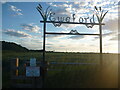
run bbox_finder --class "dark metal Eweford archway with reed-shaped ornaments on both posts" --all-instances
[36,4,108,88]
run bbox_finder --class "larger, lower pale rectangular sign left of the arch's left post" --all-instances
[26,67,40,77]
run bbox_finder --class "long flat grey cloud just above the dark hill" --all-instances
[3,29,31,37]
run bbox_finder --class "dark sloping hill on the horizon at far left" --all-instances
[0,41,29,52]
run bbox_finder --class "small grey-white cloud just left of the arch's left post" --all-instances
[21,24,41,33]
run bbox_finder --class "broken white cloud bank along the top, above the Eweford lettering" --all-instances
[49,0,118,18]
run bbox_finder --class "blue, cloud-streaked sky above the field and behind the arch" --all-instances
[0,0,120,53]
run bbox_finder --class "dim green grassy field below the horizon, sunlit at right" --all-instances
[2,51,118,88]
